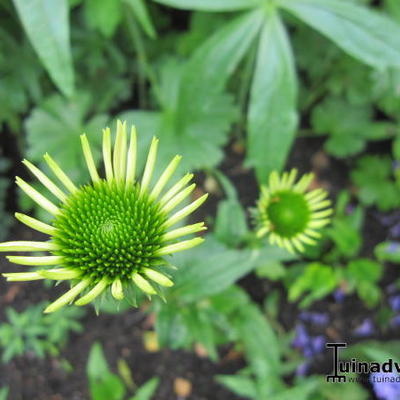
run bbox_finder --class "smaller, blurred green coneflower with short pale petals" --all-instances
[256,169,333,253]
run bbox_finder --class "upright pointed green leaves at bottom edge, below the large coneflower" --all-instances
[86,342,159,400]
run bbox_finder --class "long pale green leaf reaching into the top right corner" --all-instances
[280,0,400,68]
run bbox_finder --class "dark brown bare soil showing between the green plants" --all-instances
[0,138,399,400]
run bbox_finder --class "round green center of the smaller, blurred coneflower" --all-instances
[266,191,311,238]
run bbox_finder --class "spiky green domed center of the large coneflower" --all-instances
[53,181,166,281]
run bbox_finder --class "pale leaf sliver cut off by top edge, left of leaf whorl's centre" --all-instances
[155,0,263,11]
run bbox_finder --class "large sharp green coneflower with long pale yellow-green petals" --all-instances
[0,121,207,312]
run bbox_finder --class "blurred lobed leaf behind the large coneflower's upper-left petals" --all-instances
[26,93,109,183]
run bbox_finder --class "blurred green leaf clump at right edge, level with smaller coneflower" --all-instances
[351,155,400,211]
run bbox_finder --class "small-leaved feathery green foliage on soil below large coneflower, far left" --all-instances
[0,303,84,362]
